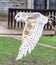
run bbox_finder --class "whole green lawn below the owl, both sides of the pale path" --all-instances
[0,36,56,65]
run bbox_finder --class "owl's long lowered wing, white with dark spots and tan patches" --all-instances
[16,14,48,60]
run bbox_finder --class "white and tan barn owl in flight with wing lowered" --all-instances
[15,12,48,60]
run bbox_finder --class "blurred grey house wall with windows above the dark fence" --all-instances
[0,0,56,14]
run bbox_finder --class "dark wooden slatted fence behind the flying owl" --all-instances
[8,8,56,30]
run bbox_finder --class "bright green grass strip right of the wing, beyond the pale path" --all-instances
[39,36,56,46]
